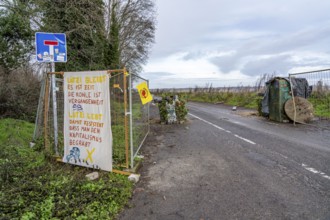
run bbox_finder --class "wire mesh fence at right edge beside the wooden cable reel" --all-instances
[289,69,330,120]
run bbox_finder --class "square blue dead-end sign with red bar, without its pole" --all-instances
[35,32,67,63]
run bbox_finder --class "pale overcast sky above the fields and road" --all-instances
[141,0,330,88]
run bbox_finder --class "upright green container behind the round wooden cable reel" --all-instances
[269,78,291,122]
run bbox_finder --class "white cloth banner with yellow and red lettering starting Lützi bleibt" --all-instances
[62,71,113,171]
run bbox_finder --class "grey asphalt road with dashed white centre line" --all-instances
[118,103,330,220]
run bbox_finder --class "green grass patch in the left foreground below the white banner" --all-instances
[0,119,132,219]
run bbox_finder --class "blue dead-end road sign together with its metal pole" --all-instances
[35,32,67,155]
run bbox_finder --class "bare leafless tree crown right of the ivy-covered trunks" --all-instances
[105,0,156,72]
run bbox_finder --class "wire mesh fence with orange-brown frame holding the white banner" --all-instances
[34,70,149,168]
